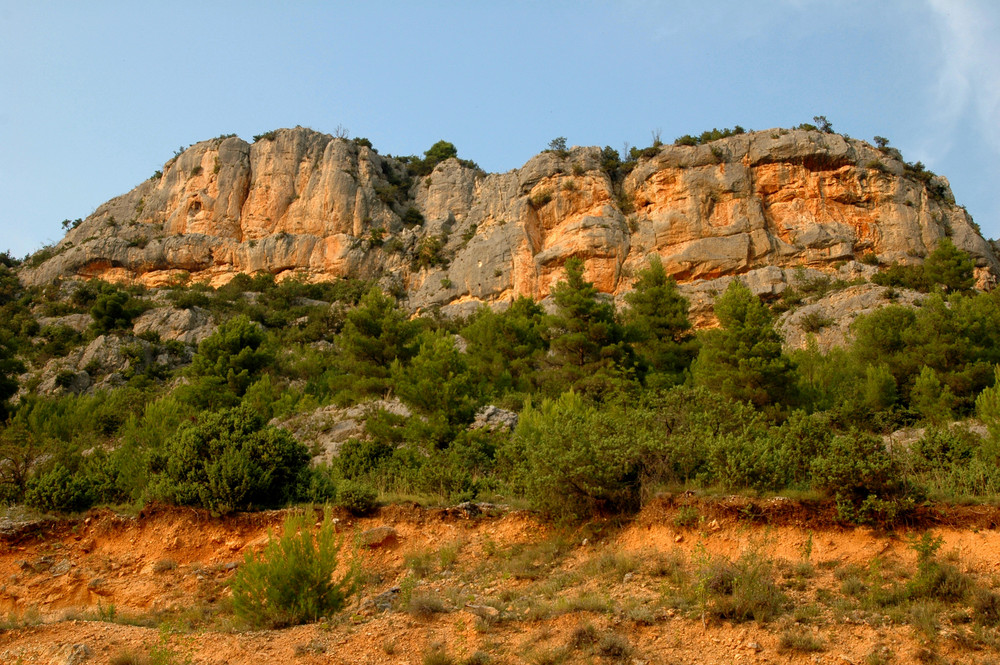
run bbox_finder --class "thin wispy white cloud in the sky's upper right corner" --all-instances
[927,0,1000,158]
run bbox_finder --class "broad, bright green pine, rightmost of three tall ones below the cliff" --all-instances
[692,280,796,407]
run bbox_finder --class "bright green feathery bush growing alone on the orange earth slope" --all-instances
[232,512,356,628]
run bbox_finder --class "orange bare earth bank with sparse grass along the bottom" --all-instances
[0,495,1000,665]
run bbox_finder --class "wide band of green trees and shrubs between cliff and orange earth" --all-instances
[0,239,1000,524]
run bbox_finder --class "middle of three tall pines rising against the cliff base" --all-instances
[625,256,698,387]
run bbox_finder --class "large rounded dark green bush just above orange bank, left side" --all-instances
[151,406,309,513]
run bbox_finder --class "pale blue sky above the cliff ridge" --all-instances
[0,0,1000,256]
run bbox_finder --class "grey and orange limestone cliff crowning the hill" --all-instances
[22,128,1000,320]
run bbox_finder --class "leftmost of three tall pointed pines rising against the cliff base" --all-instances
[546,258,635,397]
